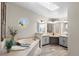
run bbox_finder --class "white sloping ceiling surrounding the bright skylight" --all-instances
[11,2,68,18]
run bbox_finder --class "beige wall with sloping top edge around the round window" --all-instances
[7,3,45,38]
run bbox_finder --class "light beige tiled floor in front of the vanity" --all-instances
[40,45,68,56]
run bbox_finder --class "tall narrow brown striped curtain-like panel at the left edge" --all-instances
[0,2,6,41]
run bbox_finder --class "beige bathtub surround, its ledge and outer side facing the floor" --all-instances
[0,38,41,56]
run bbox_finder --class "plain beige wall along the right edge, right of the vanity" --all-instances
[68,2,79,56]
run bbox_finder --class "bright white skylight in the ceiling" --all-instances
[39,2,59,11]
